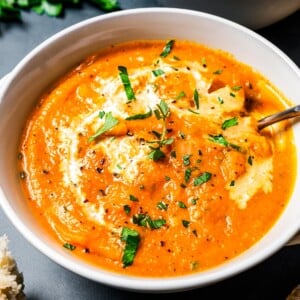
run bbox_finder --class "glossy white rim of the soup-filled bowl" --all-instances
[0,7,300,292]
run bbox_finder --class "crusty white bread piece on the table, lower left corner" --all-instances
[0,235,25,300]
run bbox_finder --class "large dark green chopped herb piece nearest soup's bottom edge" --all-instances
[121,227,140,267]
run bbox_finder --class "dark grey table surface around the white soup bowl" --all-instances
[0,0,300,300]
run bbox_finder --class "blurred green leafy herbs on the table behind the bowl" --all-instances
[0,0,120,22]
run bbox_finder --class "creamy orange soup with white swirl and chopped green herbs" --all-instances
[19,40,296,276]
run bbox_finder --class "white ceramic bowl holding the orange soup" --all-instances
[0,8,300,292]
